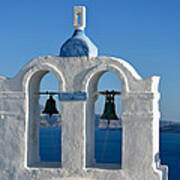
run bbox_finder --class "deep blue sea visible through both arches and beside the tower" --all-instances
[39,117,180,180]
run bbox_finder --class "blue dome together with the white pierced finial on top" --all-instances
[60,6,98,57]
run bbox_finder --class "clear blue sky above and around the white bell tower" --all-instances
[0,0,180,121]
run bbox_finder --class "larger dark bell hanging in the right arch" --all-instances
[100,91,119,125]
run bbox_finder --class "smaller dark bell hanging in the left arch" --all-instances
[42,95,59,122]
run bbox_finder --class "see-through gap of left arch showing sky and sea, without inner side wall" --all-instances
[39,72,61,163]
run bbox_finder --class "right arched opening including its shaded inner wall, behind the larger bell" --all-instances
[86,70,122,169]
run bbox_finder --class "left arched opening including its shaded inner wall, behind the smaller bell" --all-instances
[26,70,62,167]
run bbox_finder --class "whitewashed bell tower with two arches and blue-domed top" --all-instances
[0,6,167,180]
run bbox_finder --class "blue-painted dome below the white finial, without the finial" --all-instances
[60,30,98,57]
